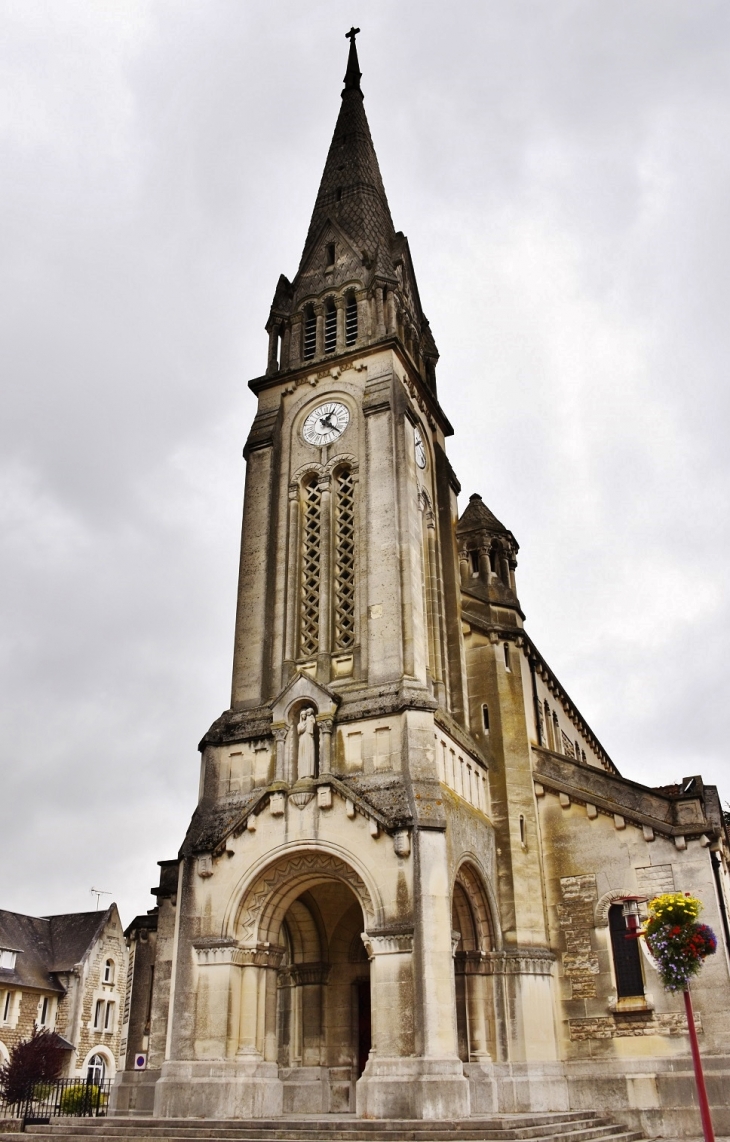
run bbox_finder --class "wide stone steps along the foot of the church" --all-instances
[2,1110,643,1142]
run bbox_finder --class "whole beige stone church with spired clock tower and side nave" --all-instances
[112,30,730,1137]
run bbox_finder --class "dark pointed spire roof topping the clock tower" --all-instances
[299,33,395,276]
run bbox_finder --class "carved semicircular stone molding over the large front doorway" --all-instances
[222,844,383,947]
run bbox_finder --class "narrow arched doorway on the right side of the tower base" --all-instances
[451,863,497,1063]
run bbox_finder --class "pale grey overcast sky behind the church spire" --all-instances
[0,0,730,923]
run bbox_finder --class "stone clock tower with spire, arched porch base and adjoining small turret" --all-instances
[117,30,562,1118]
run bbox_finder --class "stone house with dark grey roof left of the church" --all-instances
[0,904,128,1080]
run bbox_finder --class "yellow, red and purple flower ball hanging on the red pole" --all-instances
[641,892,717,991]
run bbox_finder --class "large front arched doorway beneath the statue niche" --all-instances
[230,852,375,1113]
